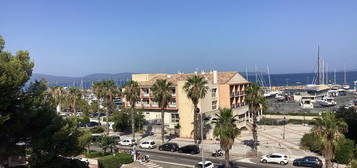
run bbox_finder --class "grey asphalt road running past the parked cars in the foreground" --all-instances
[91,146,292,168]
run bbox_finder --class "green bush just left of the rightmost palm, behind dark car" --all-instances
[300,133,322,154]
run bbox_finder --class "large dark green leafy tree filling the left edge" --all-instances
[0,37,85,167]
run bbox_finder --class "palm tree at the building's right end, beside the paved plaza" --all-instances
[245,83,266,154]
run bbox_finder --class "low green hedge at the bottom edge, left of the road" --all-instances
[98,153,133,168]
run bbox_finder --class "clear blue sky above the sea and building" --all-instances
[0,0,357,76]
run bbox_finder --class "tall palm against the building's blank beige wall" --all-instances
[183,75,208,144]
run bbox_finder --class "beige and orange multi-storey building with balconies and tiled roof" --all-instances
[124,71,250,139]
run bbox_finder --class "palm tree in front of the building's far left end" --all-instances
[123,81,140,139]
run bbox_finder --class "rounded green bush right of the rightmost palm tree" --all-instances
[335,138,355,164]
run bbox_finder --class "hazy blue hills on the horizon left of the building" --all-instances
[30,72,133,83]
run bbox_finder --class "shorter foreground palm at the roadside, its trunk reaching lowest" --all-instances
[213,108,240,167]
